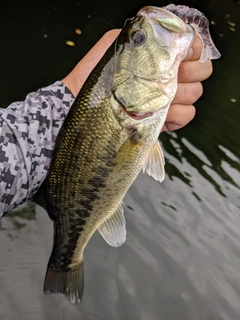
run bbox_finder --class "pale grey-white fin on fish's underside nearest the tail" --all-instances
[98,204,127,247]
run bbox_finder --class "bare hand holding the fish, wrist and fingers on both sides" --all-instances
[62,29,212,131]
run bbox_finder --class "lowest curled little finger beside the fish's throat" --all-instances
[162,104,196,132]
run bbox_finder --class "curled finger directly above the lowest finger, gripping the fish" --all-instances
[172,82,203,105]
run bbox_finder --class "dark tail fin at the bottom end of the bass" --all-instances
[44,261,84,304]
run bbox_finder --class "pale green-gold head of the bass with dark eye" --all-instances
[111,6,195,134]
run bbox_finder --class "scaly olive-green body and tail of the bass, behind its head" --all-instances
[36,41,149,303]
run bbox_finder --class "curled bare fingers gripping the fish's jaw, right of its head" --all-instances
[162,36,212,131]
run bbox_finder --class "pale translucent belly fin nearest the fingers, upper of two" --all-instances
[143,140,165,182]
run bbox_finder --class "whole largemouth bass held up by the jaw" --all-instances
[35,5,219,304]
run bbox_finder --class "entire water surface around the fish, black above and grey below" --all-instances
[0,0,240,320]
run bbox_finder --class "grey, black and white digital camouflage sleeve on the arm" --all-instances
[0,81,74,219]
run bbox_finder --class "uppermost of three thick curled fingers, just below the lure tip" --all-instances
[178,60,213,82]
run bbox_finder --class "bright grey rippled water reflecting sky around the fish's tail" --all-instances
[0,133,240,320]
